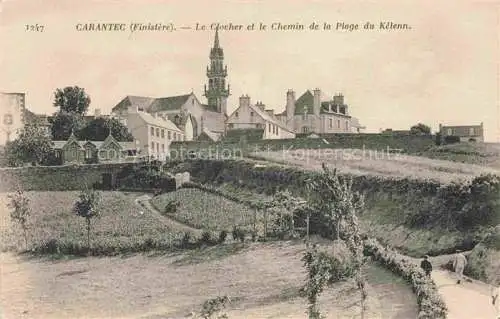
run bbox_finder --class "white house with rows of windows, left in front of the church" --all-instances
[125,107,185,160]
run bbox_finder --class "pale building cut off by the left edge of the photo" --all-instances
[0,92,26,145]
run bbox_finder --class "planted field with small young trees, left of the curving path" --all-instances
[0,191,187,253]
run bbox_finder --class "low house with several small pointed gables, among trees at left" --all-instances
[53,133,137,165]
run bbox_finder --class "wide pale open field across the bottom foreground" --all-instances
[0,242,416,319]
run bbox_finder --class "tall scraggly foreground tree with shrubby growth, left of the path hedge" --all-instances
[303,164,367,318]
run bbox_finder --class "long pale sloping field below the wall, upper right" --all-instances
[252,149,500,183]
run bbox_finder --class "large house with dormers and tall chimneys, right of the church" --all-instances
[276,89,364,134]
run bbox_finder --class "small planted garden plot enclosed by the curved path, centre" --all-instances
[152,188,254,231]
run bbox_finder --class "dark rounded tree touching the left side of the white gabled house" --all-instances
[78,118,134,142]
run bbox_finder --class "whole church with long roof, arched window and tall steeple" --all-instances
[111,30,230,141]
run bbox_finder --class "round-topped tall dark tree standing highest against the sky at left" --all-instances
[54,86,90,116]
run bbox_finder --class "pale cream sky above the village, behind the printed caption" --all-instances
[0,0,500,142]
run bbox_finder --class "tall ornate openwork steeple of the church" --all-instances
[204,28,230,114]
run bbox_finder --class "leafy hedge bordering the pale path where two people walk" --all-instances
[365,239,448,319]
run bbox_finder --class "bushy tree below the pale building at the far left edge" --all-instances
[5,123,52,166]
